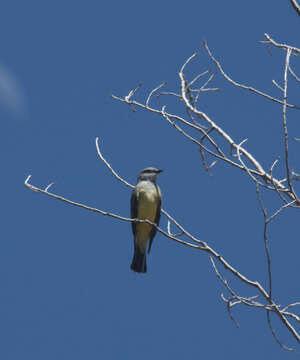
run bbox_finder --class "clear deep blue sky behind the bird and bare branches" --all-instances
[0,0,300,360]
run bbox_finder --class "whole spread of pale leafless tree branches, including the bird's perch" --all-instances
[25,34,300,351]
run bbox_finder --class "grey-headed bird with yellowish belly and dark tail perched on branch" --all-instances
[130,167,162,273]
